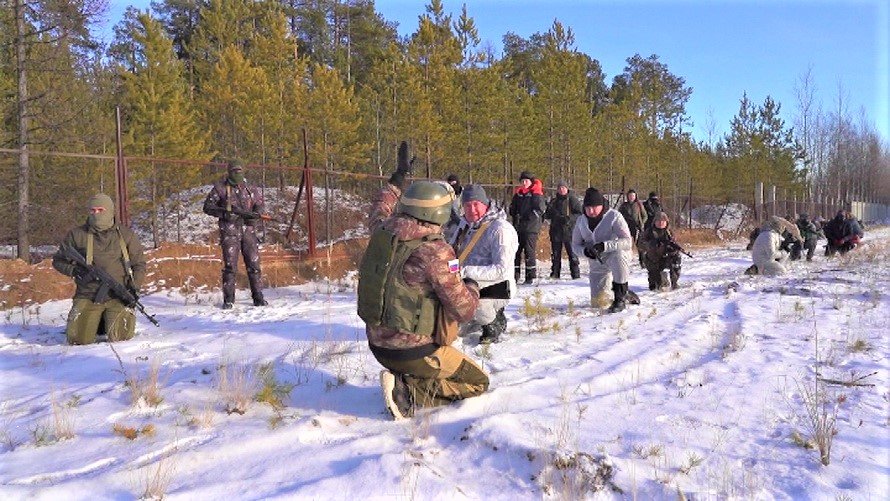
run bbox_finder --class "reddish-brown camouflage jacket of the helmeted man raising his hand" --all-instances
[365,185,479,349]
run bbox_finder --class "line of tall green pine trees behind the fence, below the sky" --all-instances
[0,0,890,256]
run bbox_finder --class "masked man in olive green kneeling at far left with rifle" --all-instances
[53,194,145,344]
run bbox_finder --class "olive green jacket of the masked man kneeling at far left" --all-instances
[53,224,145,301]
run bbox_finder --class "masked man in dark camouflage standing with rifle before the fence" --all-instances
[204,160,269,310]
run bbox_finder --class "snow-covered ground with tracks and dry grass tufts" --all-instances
[0,229,890,499]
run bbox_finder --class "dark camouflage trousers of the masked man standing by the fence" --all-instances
[219,223,263,303]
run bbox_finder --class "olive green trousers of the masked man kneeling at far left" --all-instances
[65,299,136,344]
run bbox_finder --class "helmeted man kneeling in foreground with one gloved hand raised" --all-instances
[358,143,489,419]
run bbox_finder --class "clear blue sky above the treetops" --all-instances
[102,0,890,145]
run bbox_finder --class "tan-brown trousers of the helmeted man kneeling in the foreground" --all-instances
[375,346,489,408]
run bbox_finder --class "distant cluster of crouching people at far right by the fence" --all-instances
[745,210,865,276]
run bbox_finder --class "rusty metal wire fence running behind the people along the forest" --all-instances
[0,149,850,257]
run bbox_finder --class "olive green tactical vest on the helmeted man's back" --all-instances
[358,229,442,336]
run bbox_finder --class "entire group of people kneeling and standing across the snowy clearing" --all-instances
[53,143,863,419]
